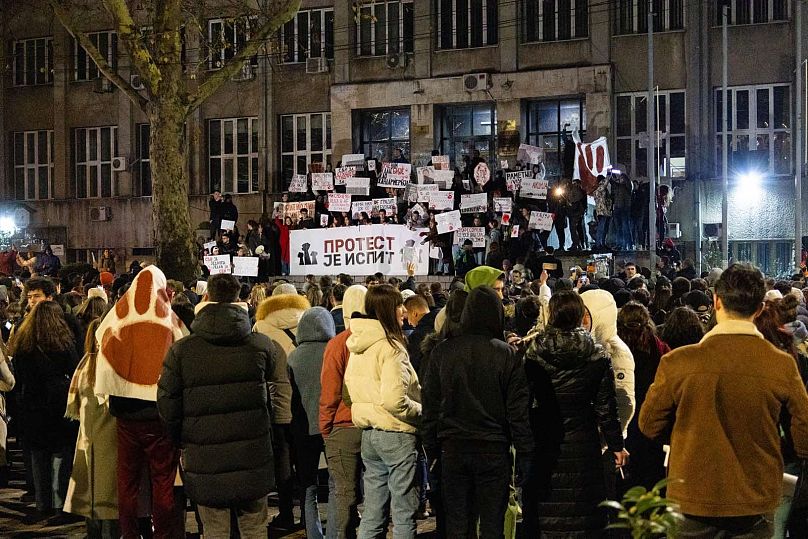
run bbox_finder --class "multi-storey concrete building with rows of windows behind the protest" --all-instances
[0,0,808,272]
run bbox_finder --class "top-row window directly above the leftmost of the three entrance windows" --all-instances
[356,1,414,56]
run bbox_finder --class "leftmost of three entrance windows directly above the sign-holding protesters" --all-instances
[358,108,410,162]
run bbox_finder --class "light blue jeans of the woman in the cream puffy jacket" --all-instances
[359,430,418,539]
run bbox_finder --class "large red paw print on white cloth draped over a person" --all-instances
[100,270,181,385]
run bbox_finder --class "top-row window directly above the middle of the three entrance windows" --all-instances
[436,0,497,49]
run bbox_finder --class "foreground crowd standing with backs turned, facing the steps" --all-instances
[0,254,808,539]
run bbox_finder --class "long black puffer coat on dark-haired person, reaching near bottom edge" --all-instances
[525,328,623,537]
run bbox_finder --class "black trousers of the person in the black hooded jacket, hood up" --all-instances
[441,444,511,539]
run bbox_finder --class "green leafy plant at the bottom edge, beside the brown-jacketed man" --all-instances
[600,479,683,539]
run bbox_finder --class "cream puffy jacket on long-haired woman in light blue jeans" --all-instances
[345,318,421,433]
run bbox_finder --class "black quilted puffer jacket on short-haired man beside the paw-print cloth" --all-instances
[157,303,278,507]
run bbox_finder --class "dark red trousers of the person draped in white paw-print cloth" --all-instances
[118,418,181,539]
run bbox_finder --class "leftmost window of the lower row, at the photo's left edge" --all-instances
[14,130,53,200]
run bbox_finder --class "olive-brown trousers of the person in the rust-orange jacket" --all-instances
[325,427,362,539]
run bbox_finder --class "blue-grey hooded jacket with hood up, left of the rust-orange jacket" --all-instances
[288,307,335,436]
